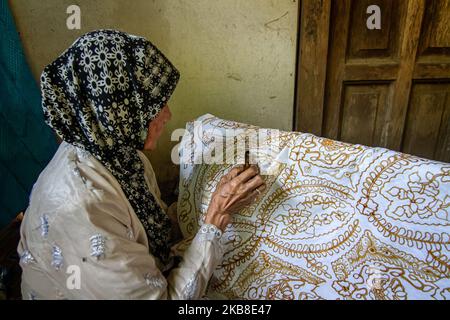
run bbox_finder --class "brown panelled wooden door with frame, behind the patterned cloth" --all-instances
[296,0,450,162]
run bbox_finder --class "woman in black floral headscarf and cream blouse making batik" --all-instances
[18,30,265,299]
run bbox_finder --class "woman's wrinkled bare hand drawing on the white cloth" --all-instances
[205,165,266,231]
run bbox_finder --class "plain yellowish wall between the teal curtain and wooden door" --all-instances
[9,0,298,186]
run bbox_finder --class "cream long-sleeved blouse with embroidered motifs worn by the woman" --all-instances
[18,142,223,299]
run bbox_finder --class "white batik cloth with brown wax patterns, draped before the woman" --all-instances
[178,115,450,299]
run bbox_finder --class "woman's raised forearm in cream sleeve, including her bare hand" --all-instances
[168,166,265,299]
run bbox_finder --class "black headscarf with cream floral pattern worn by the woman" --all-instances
[41,30,180,263]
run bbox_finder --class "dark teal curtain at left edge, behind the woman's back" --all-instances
[0,0,57,227]
